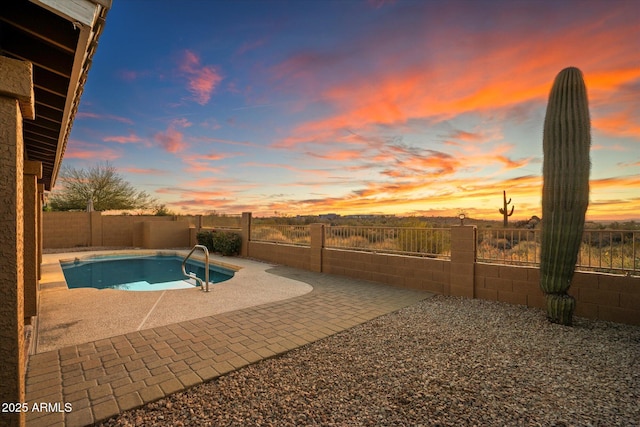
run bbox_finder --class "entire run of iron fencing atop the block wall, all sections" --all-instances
[251,224,640,275]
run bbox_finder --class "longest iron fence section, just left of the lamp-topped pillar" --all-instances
[324,226,451,258]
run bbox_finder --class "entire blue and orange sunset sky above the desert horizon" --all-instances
[63,0,640,220]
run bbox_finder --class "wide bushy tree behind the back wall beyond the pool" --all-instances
[48,162,155,211]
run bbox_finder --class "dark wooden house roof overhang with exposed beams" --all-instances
[0,0,112,190]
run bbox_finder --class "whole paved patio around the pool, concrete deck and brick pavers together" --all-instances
[26,251,432,426]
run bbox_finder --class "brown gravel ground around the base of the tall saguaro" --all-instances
[99,296,640,426]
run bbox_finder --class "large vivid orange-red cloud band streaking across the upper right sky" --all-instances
[274,3,640,152]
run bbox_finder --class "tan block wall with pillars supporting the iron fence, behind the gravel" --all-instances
[242,213,640,325]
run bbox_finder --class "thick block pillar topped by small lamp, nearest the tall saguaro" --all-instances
[449,225,477,298]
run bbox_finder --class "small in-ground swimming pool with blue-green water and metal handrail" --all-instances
[60,254,234,291]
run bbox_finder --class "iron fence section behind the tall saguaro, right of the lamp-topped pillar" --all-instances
[477,229,640,275]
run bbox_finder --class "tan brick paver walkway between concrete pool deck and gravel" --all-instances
[27,267,432,427]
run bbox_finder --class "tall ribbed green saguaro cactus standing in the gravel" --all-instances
[540,67,591,325]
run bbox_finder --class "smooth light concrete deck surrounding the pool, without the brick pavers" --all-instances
[32,250,312,353]
